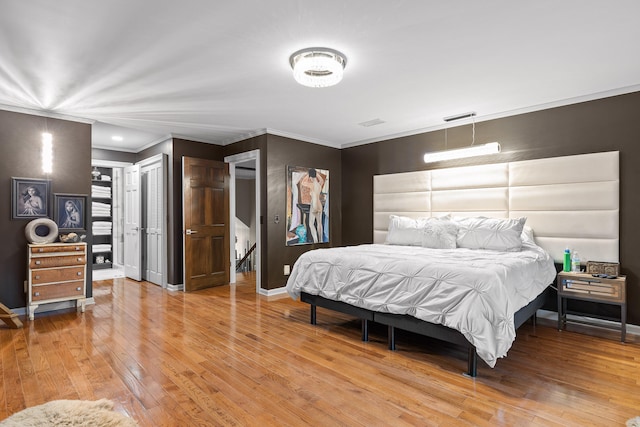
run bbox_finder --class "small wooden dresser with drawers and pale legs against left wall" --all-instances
[26,243,87,320]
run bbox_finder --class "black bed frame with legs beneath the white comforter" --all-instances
[300,288,549,377]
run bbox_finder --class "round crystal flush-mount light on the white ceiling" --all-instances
[289,47,347,87]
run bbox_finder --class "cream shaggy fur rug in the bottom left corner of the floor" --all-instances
[0,399,138,427]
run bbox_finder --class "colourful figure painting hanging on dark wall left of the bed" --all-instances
[285,166,329,246]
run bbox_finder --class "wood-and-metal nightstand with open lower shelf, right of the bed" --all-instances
[558,271,627,342]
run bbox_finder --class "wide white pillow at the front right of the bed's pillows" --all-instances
[456,217,527,251]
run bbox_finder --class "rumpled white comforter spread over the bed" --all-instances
[287,242,556,367]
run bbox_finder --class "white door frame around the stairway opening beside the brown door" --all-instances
[224,149,262,294]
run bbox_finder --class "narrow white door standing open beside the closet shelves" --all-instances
[124,165,142,281]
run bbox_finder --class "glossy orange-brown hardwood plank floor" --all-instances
[0,276,640,426]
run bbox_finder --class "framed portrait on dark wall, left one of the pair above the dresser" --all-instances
[11,177,51,219]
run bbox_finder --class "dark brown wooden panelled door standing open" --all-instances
[182,157,230,292]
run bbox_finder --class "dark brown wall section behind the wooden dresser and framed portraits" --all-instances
[0,111,92,308]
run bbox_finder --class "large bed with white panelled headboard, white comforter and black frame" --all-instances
[287,152,619,376]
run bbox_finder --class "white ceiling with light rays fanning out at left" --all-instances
[0,0,640,152]
